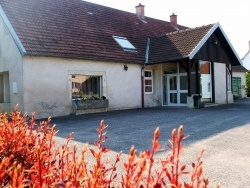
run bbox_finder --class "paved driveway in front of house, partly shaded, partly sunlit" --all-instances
[52,98,250,188]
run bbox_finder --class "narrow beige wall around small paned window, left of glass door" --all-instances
[144,64,162,107]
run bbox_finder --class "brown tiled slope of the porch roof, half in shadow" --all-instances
[149,24,214,63]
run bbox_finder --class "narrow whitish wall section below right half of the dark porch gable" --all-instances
[214,63,233,104]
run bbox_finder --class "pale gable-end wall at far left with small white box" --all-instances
[0,17,23,113]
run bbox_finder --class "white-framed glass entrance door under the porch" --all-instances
[163,74,187,106]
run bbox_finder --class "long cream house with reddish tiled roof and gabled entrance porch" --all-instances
[0,0,241,118]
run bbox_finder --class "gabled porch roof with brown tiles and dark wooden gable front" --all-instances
[148,23,242,65]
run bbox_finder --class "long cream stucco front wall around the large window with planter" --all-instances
[23,56,141,118]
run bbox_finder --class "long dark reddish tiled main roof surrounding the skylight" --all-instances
[0,0,188,63]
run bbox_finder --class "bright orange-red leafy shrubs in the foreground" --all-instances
[0,110,219,188]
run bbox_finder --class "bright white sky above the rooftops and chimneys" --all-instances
[87,0,250,58]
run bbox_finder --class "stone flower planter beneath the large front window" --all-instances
[72,99,109,115]
